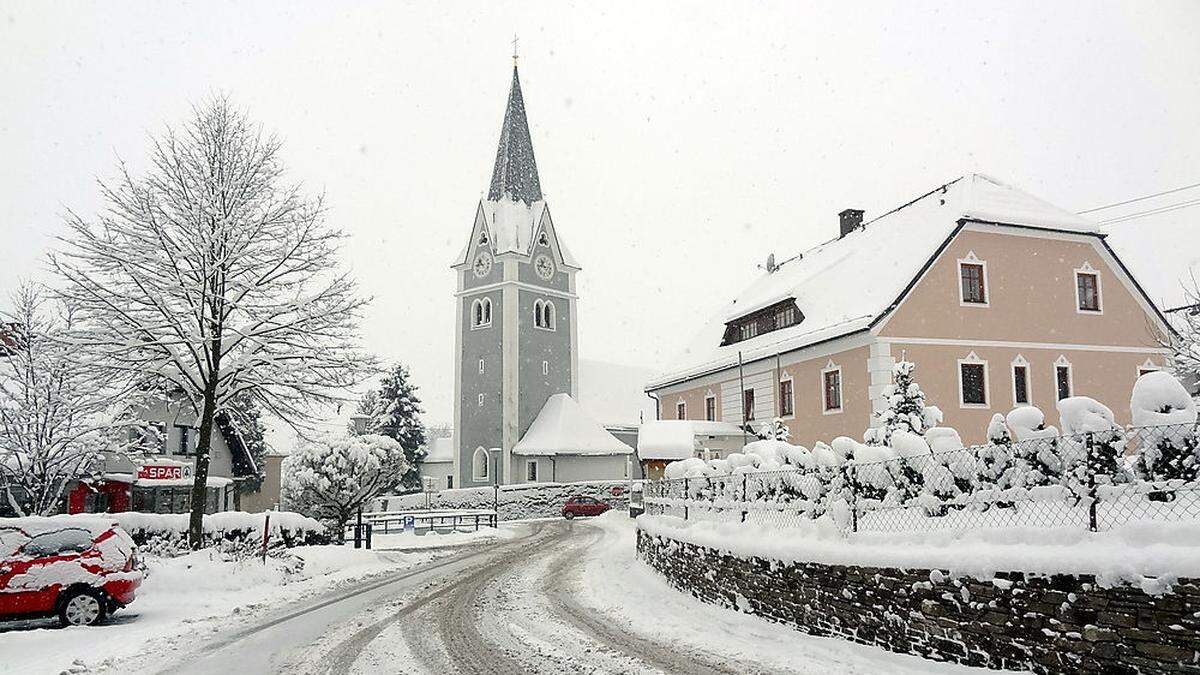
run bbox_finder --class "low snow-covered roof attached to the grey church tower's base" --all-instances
[512,394,634,455]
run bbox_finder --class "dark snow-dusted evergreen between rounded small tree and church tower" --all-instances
[350,365,428,490]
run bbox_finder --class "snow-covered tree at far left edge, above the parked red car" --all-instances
[0,283,120,515]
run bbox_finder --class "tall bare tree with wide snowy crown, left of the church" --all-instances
[52,98,371,548]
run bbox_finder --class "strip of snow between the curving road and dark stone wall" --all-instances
[578,513,983,674]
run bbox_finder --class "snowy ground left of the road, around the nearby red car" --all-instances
[0,546,434,675]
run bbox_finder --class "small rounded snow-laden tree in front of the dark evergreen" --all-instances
[281,434,410,540]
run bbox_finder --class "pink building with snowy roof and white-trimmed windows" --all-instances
[646,174,1172,446]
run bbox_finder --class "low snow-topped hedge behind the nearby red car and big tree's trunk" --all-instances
[0,510,329,556]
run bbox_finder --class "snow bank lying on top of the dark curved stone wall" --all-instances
[637,515,1200,585]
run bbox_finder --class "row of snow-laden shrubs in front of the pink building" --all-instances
[647,374,1200,526]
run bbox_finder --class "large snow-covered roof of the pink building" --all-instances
[647,174,1098,388]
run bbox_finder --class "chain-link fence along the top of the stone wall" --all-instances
[646,424,1200,532]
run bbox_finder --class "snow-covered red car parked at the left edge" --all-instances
[0,518,144,626]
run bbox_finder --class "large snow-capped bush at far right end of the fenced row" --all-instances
[1129,371,1200,480]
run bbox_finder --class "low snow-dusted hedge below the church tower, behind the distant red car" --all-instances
[372,480,630,520]
